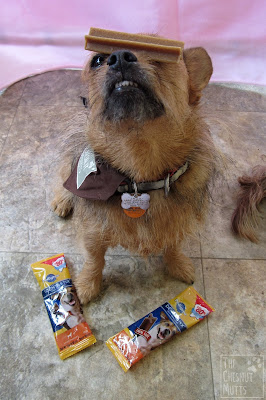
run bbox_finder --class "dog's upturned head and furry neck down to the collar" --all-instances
[83,38,212,181]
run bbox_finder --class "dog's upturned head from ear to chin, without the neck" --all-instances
[83,40,212,123]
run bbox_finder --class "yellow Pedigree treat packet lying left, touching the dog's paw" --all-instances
[31,254,96,360]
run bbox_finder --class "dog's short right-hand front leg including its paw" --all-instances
[164,245,195,284]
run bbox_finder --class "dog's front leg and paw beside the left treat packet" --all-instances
[75,238,107,304]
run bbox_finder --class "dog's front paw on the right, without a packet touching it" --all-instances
[167,254,195,285]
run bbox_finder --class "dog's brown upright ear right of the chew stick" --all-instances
[184,47,213,104]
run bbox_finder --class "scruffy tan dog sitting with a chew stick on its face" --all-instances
[52,43,215,303]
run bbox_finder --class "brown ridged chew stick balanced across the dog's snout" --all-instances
[85,28,184,62]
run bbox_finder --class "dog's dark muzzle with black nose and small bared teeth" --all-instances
[103,50,164,122]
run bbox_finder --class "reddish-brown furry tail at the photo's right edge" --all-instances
[232,165,266,243]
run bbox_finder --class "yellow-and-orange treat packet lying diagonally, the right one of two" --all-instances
[106,286,214,372]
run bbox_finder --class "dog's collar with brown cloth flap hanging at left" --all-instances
[63,157,189,200]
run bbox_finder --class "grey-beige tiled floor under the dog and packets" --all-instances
[0,71,266,400]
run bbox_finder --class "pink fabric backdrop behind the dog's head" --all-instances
[0,0,266,89]
